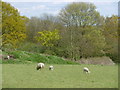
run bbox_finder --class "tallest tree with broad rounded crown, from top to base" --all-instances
[59,2,105,60]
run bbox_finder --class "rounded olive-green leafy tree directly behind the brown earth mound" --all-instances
[82,27,106,56]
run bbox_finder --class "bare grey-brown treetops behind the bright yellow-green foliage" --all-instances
[27,14,62,42]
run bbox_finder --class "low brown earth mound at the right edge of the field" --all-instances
[77,56,115,65]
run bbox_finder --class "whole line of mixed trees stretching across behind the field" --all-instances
[2,2,118,62]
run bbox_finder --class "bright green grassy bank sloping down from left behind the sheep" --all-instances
[0,51,79,64]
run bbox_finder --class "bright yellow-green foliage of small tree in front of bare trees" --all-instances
[35,29,60,47]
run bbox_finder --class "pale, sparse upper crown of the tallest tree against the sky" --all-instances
[59,2,103,27]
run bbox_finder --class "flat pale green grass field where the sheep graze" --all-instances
[2,64,118,88]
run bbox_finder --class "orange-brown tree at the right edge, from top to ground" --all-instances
[103,15,119,62]
